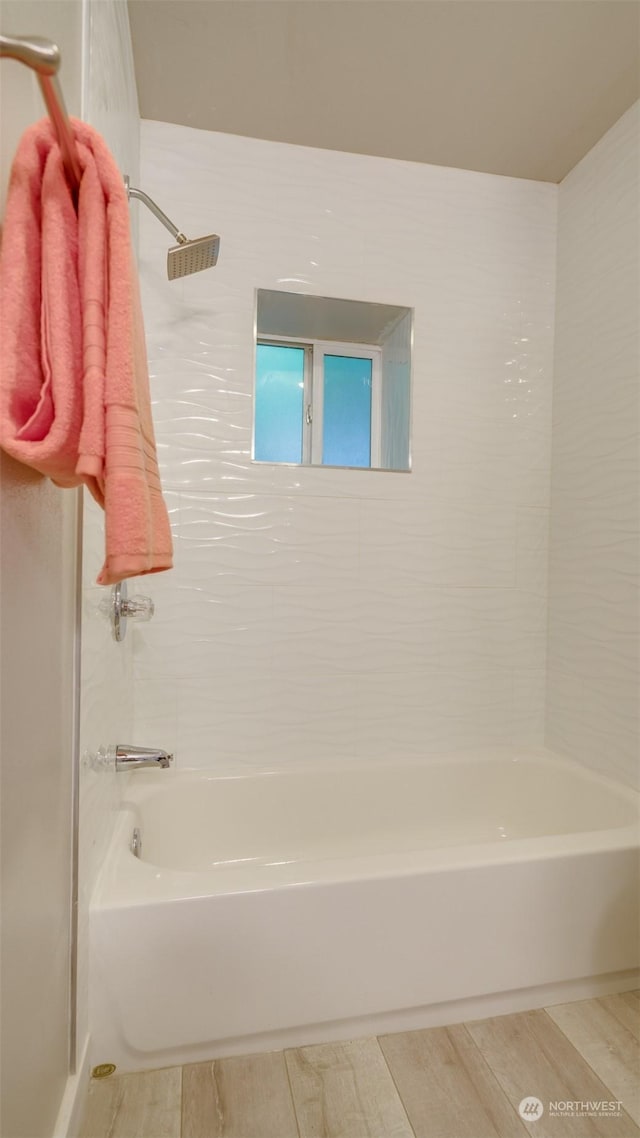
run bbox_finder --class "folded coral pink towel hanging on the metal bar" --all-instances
[0,118,172,585]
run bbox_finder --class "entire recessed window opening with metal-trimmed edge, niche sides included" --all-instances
[253,289,412,471]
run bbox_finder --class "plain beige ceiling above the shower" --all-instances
[129,0,640,182]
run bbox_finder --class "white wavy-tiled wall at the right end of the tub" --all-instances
[547,104,640,782]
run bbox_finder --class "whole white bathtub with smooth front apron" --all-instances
[90,749,639,1071]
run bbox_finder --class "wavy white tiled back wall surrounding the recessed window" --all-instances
[134,122,557,766]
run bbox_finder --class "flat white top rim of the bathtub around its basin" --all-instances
[92,748,640,909]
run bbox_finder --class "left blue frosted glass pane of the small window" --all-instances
[254,344,304,462]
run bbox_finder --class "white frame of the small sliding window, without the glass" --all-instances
[254,336,383,470]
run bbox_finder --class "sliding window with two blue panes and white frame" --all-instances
[254,339,380,467]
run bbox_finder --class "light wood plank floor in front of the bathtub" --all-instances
[80,991,640,1138]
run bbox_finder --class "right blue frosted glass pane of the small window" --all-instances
[322,355,372,467]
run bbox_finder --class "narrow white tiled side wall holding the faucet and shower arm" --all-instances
[77,0,140,1065]
